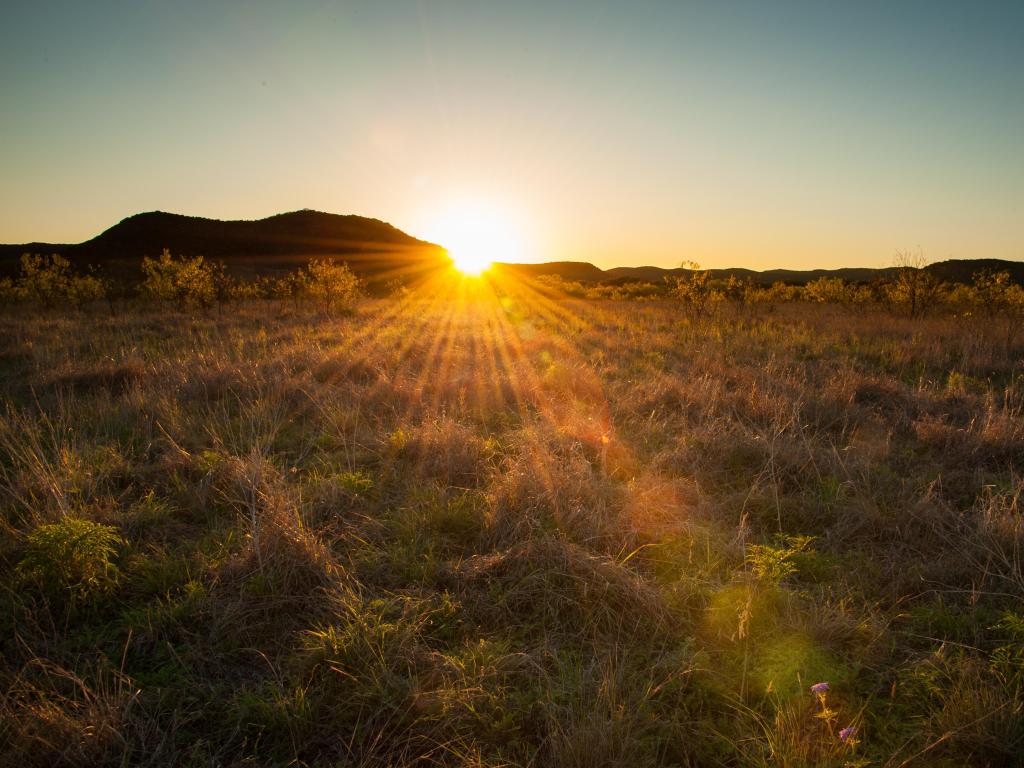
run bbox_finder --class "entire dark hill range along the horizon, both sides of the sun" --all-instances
[0,209,1024,285]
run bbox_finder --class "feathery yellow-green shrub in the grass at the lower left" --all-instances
[17,517,123,603]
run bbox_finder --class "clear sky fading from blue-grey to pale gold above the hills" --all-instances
[0,0,1024,269]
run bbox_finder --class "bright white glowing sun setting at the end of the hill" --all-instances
[421,203,523,276]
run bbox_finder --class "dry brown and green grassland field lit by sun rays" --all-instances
[0,282,1024,768]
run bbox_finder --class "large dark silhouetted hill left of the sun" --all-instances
[0,210,450,278]
